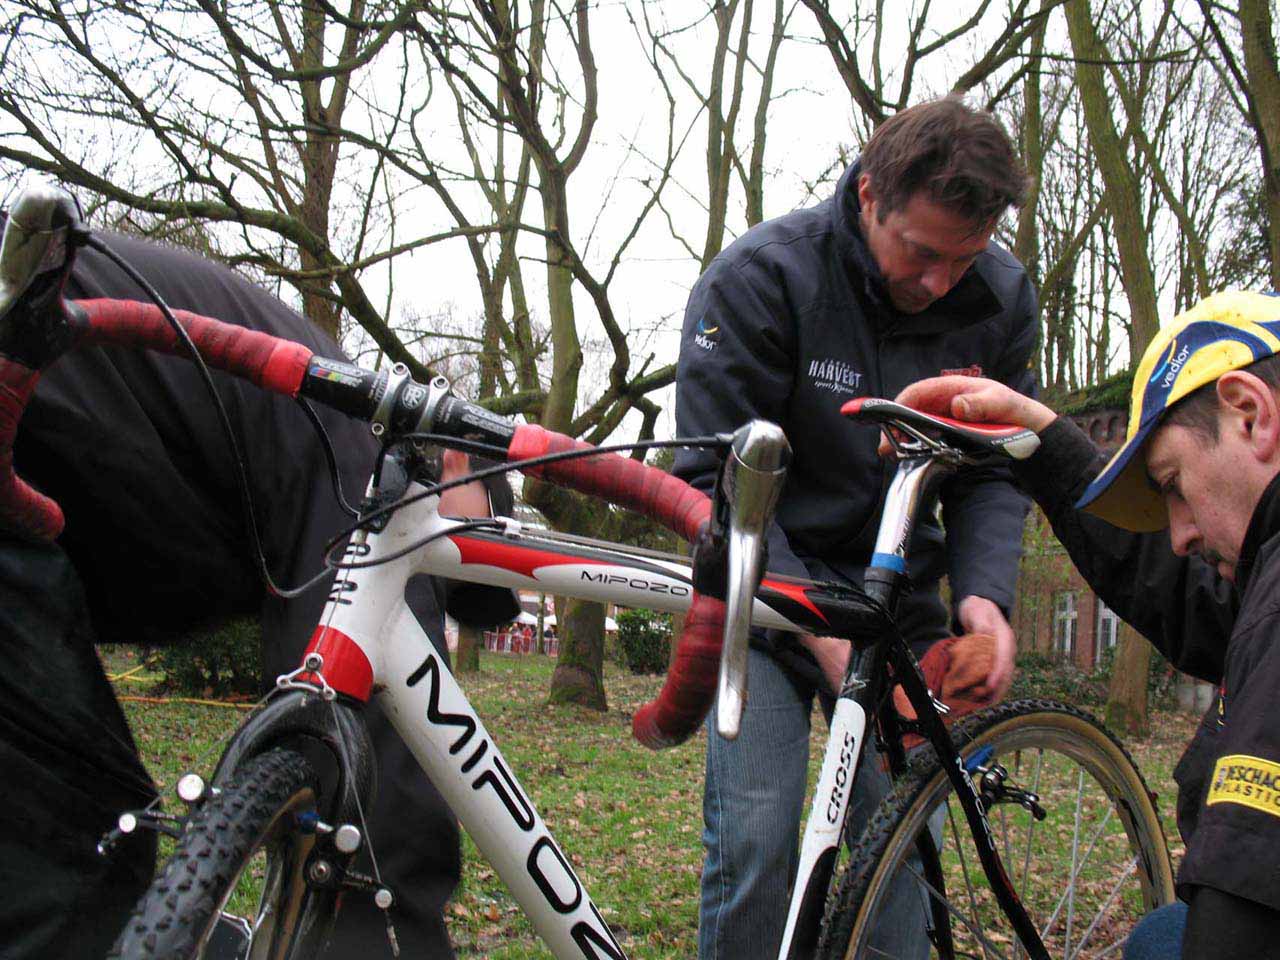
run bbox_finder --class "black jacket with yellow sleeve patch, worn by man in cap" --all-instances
[1015,419,1280,957]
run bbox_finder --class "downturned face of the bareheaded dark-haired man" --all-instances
[858,174,996,314]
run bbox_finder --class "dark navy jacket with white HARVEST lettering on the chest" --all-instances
[675,164,1037,675]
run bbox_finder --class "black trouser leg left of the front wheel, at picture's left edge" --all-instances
[0,540,155,960]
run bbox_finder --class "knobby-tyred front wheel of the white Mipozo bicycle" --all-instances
[110,750,335,960]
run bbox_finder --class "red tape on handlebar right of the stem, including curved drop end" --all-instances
[507,425,724,750]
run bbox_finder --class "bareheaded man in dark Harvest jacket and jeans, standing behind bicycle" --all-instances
[675,97,1037,960]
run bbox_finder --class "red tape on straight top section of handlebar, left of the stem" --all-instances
[79,300,312,397]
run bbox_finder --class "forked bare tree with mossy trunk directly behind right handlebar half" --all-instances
[417,0,696,709]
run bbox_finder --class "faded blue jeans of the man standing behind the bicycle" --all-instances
[698,649,928,960]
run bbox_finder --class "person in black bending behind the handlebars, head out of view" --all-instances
[0,218,518,960]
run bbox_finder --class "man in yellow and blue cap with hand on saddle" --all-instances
[899,292,1280,960]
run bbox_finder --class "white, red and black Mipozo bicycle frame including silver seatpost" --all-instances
[267,437,1039,960]
